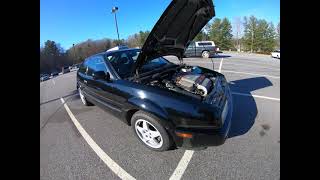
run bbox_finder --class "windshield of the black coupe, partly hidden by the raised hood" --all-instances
[105,49,170,78]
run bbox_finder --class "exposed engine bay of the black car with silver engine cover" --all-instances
[146,65,216,99]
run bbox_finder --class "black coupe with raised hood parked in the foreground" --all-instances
[77,0,233,151]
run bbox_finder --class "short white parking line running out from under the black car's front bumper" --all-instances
[169,150,194,180]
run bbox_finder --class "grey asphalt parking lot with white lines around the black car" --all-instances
[40,53,280,179]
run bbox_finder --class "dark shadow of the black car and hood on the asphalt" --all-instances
[228,77,273,138]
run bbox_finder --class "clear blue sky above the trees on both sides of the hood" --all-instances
[40,0,280,50]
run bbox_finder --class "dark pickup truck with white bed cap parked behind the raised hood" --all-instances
[184,41,219,58]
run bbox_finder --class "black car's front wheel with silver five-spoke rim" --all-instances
[131,111,173,151]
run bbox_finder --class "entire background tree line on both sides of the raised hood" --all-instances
[40,16,280,73]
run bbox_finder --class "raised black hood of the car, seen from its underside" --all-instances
[133,0,215,73]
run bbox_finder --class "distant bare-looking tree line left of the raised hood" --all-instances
[40,31,150,73]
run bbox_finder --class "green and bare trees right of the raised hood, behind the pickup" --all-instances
[195,16,280,54]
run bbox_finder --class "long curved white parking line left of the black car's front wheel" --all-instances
[61,98,135,180]
